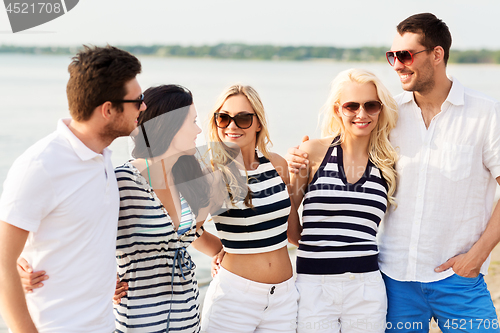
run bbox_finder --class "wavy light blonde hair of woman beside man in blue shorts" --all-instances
[321,68,398,206]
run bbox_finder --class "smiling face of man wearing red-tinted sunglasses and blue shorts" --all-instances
[391,32,434,94]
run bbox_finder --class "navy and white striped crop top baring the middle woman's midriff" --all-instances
[213,152,290,254]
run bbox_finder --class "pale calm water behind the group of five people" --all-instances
[0,54,500,332]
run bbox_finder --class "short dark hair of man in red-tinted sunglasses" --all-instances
[397,13,451,65]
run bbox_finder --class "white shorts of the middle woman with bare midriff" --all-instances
[201,267,299,333]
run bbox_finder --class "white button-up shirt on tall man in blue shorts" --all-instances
[378,79,500,282]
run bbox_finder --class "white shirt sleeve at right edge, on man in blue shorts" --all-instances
[483,102,500,178]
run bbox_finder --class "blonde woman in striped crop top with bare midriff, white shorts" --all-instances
[201,85,298,333]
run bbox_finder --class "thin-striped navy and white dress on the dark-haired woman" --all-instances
[115,163,200,333]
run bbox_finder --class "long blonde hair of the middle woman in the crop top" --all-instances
[208,84,272,207]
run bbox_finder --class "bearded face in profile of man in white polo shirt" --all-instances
[105,79,146,139]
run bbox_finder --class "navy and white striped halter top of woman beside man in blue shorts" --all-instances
[297,141,387,275]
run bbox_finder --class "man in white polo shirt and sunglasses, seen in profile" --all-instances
[0,46,146,333]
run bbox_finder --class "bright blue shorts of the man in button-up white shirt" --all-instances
[383,274,500,333]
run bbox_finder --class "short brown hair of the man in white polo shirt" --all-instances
[66,45,141,121]
